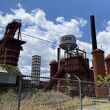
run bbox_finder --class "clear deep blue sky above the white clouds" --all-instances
[0,0,110,42]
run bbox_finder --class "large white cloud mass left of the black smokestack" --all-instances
[0,5,90,75]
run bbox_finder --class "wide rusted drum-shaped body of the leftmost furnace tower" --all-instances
[0,38,26,66]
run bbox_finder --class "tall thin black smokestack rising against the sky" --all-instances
[90,15,97,50]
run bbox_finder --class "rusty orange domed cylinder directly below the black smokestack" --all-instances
[92,49,106,98]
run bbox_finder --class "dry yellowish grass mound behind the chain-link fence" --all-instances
[0,91,94,110]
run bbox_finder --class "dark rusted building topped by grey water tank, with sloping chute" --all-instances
[46,35,90,90]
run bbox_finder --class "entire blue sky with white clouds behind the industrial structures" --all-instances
[0,0,110,74]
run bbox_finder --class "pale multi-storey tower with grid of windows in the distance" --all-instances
[31,55,41,83]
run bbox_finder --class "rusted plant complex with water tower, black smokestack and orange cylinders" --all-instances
[45,15,110,98]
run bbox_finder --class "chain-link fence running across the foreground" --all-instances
[0,74,108,110]
